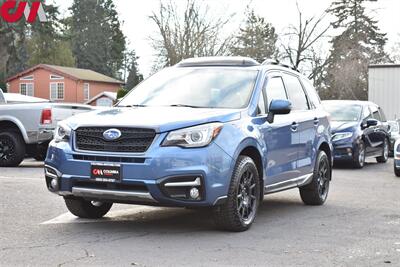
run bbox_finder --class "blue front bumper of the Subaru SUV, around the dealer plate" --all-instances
[45,134,233,206]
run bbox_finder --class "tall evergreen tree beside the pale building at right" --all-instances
[323,0,388,100]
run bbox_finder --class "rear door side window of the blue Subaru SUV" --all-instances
[285,75,309,110]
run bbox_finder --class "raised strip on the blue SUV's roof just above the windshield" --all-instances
[175,57,260,67]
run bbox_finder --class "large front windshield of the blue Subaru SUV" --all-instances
[118,68,258,108]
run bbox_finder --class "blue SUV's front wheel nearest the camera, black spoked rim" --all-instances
[213,156,260,232]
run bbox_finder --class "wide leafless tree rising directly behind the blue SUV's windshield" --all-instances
[150,0,232,68]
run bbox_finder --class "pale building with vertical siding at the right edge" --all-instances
[368,64,400,120]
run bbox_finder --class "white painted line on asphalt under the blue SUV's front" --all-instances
[40,206,161,225]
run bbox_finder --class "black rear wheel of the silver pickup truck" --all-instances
[0,132,25,167]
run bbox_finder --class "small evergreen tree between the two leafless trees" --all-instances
[231,10,278,62]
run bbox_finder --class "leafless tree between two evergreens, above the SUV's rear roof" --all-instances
[282,3,331,74]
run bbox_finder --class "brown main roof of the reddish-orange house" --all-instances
[7,64,124,84]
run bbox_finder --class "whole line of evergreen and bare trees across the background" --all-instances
[0,0,400,100]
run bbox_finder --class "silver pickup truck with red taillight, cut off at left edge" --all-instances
[0,89,93,167]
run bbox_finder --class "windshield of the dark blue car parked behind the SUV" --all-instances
[324,104,362,121]
